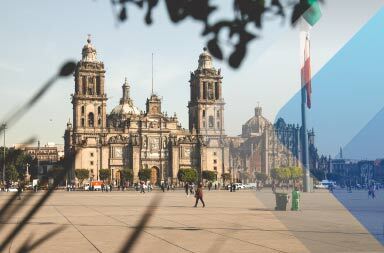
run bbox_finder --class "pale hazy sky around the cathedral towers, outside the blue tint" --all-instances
[0,0,383,156]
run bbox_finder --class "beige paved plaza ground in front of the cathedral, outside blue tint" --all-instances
[0,189,384,253]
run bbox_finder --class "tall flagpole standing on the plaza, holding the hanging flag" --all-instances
[301,31,311,192]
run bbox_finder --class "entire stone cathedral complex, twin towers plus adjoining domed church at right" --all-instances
[64,36,314,184]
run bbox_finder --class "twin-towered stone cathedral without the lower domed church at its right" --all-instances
[64,38,230,184]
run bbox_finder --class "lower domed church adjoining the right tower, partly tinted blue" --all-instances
[229,106,317,182]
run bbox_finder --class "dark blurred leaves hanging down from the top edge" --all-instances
[111,0,323,68]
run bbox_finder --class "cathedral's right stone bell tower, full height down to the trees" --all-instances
[188,48,229,180]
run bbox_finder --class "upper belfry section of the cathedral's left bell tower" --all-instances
[72,36,107,132]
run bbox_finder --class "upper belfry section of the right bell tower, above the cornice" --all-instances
[188,48,225,138]
